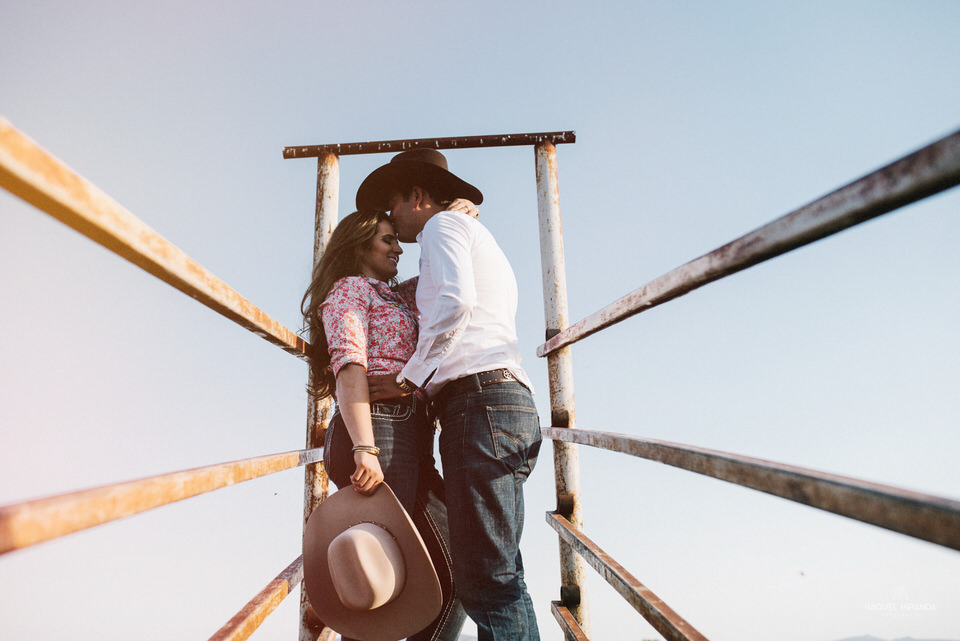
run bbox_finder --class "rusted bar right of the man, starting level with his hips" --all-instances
[542,428,960,550]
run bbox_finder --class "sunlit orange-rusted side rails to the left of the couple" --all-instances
[0,118,318,641]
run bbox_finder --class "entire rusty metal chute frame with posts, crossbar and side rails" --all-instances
[0,119,960,641]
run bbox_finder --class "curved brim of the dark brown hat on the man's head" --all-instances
[357,160,483,211]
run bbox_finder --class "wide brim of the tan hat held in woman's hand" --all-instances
[303,483,442,641]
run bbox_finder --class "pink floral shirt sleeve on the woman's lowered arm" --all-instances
[320,277,371,376]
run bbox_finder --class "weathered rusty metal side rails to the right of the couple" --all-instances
[537,126,960,641]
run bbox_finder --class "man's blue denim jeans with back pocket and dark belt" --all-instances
[434,382,541,641]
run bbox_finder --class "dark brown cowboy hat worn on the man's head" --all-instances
[357,149,483,211]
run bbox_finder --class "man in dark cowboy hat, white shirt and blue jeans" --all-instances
[357,149,541,641]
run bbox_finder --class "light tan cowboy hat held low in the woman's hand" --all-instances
[303,483,442,641]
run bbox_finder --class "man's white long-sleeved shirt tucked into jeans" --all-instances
[402,212,530,396]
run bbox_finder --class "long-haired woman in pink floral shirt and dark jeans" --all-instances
[301,204,466,641]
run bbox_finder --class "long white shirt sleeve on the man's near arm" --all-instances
[403,212,477,387]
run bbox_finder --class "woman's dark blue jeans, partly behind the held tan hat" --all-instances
[323,399,467,641]
